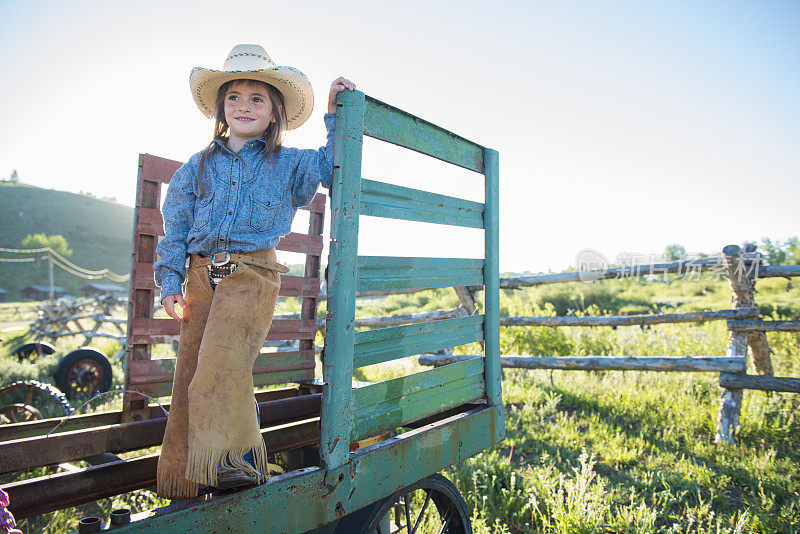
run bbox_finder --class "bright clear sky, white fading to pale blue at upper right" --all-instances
[0,0,800,271]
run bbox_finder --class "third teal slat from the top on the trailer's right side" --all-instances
[357,256,484,291]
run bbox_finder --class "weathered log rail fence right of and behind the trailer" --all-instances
[412,245,800,443]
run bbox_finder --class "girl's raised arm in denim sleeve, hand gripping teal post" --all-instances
[292,77,356,208]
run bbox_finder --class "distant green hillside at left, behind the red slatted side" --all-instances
[0,182,133,300]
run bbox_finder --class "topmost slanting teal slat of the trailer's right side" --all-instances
[364,97,483,173]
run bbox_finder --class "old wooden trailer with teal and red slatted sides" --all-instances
[0,91,505,534]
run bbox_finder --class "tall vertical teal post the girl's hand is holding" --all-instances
[320,91,364,469]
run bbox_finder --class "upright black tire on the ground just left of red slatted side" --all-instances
[53,347,113,400]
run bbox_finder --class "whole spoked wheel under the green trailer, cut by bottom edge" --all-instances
[336,474,472,534]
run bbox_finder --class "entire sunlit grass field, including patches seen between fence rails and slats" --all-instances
[0,280,800,534]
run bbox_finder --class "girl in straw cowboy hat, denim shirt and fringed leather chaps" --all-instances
[153,45,355,498]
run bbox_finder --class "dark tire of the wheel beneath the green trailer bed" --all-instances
[336,474,472,534]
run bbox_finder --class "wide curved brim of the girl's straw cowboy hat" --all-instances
[189,66,314,130]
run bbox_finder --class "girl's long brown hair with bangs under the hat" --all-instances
[197,79,289,197]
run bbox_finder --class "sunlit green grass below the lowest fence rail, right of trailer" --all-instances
[448,370,800,533]
